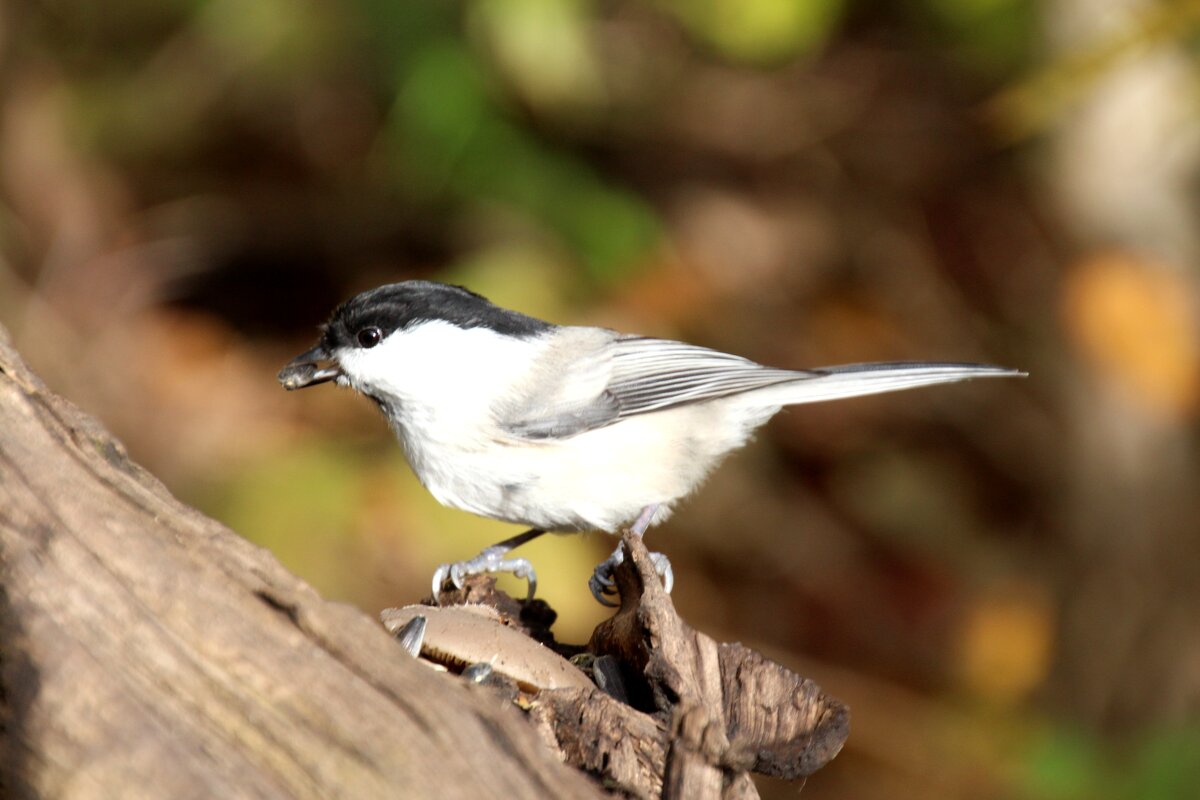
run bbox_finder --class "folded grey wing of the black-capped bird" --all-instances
[502,333,811,439]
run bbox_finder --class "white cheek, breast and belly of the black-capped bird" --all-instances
[340,321,774,531]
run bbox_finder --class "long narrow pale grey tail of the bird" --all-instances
[764,361,1027,405]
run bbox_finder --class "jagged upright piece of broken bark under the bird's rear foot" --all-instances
[589,535,850,798]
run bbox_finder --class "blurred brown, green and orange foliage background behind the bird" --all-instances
[0,0,1200,799]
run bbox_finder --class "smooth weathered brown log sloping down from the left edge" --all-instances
[0,330,601,799]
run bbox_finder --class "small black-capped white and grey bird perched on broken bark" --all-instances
[278,281,1025,604]
